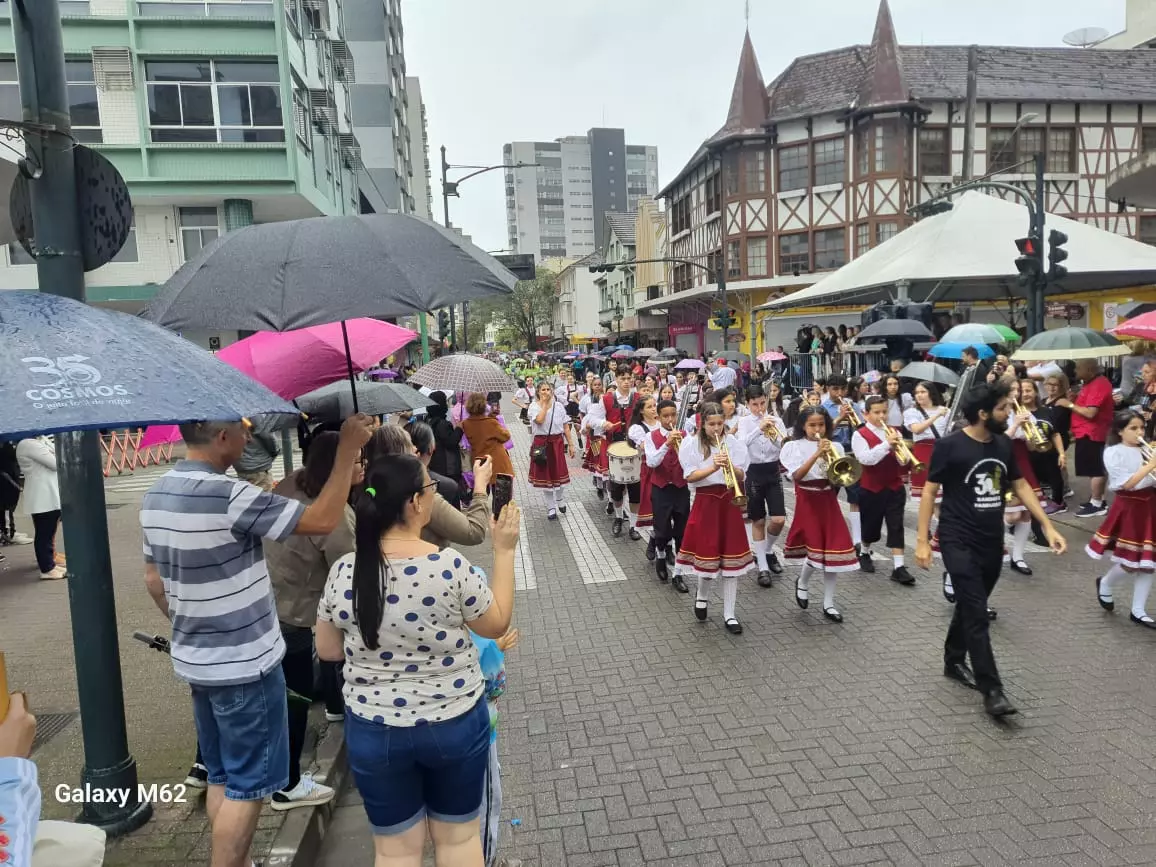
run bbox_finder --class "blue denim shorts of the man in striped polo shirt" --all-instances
[193,665,289,801]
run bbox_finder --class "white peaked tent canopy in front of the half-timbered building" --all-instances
[758,191,1156,310]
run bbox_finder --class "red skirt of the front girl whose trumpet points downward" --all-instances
[677,484,755,578]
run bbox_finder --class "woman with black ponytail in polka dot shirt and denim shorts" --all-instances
[316,454,520,867]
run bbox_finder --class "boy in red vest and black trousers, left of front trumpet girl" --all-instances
[644,400,690,593]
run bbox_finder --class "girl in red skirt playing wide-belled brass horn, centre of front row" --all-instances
[779,407,859,623]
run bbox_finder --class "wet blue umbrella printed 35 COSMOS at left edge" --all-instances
[0,291,298,439]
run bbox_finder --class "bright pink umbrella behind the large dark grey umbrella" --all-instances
[217,319,417,400]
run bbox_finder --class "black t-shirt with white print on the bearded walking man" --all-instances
[927,430,1020,550]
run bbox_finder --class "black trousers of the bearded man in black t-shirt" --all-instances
[940,538,1003,695]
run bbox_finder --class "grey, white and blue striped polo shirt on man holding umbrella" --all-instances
[141,460,305,687]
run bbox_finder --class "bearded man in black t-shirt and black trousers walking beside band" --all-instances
[916,383,1067,717]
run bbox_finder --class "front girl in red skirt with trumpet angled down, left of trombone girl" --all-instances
[677,403,755,635]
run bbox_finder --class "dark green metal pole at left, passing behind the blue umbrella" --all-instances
[12,0,153,836]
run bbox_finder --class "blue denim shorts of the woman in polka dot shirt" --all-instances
[346,698,490,837]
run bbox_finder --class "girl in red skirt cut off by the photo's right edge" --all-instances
[1084,410,1156,629]
